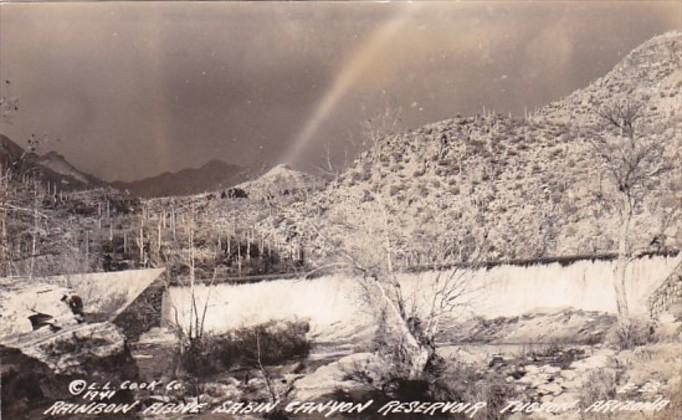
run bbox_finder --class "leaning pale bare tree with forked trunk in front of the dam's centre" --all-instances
[306,186,480,380]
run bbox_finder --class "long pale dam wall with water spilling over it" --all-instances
[162,255,682,336]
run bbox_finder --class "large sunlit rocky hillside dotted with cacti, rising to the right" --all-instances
[248,32,682,264]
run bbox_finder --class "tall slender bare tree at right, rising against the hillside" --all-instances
[590,99,674,319]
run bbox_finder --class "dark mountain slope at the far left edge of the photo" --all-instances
[0,134,106,191]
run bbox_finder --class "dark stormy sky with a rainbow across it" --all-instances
[0,1,682,181]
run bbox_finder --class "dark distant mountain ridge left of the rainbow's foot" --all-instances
[112,160,250,198]
